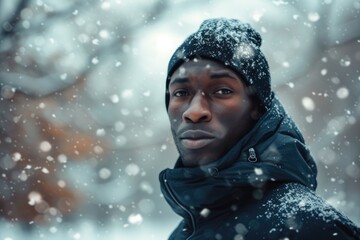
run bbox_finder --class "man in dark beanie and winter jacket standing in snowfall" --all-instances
[160,18,360,240]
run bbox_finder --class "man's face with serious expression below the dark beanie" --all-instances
[168,59,257,166]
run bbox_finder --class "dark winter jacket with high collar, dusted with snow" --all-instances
[160,98,360,240]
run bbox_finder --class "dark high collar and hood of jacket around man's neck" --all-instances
[160,94,317,215]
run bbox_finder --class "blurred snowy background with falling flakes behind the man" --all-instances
[0,0,360,240]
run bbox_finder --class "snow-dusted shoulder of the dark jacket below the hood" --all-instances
[259,183,360,239]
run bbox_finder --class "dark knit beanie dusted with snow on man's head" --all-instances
[165,18,272,109]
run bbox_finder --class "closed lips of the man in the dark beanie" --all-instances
[180,130,215,149]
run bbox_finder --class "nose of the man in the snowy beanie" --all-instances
[183,93,211,123]
